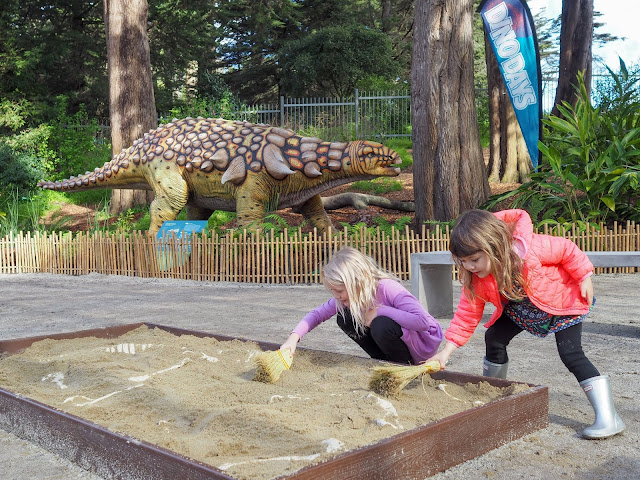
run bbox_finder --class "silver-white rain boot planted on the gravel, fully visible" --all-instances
[580,375,625,439]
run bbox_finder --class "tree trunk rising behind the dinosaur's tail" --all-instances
[104,0,158,214]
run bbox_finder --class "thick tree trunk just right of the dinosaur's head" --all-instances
[411,0,490,229]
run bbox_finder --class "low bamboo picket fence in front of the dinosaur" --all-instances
[0,222,640,284]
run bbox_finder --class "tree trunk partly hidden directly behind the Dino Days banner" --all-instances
[485,35,532,183]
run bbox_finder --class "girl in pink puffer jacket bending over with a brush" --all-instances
[432,210,625,438]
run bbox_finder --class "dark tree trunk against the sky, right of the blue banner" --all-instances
[551,0,593,116]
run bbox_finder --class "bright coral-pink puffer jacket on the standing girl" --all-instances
[445,210,593,347]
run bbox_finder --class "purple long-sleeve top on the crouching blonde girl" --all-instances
[292,278,442,363]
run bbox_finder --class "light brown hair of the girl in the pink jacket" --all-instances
[449,210,525,300]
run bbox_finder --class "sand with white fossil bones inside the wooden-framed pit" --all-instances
[0,326,529,480]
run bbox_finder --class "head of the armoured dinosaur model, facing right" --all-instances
[343,140,402,177]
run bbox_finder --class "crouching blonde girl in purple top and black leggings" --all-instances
[281,247,442,364]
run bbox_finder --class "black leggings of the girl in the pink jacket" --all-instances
[484,315,600,382]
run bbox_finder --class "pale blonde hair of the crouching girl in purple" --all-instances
[323,247,398,334]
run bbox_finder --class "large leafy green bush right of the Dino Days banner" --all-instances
[485,60,640,223]
